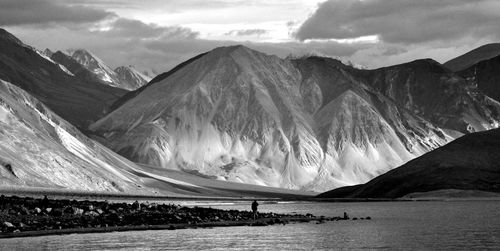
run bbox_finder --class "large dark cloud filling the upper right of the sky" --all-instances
[295,0,500,44]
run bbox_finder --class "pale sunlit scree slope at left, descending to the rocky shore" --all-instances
[0,80,147,192]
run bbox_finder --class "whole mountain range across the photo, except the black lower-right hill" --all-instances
[0,30,500,196]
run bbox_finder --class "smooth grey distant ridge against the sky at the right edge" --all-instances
[444,43,500,72]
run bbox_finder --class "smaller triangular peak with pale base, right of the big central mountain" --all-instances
[294,57,451,190]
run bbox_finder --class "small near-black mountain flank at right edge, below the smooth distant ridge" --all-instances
[458,56,500,102]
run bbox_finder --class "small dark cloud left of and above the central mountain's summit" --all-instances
[95,18,199,39]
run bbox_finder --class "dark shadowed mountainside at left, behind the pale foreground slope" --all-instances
[0,29,125,128]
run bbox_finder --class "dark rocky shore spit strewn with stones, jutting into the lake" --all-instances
[0,196,370,238]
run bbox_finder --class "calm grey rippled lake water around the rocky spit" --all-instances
[0,201,500,250]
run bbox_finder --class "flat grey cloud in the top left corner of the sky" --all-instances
[0,0,115,26]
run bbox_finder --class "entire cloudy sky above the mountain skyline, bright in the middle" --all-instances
[0,0,500,72]
